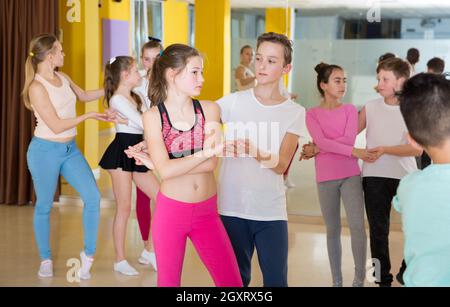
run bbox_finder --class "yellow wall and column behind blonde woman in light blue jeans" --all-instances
[59,0,131,169]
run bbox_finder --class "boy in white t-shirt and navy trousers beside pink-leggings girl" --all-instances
[218,33,306,287]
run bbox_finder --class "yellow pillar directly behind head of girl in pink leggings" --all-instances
[195,0,231,100]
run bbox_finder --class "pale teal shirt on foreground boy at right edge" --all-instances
[393,164,450,287]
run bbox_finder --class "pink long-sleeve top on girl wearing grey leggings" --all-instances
[306,104,361,182]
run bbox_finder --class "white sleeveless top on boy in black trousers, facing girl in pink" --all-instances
[362,98,417,179]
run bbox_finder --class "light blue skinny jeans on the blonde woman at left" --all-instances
[27,137,100,260]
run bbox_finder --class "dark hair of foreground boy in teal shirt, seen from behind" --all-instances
[399,73,450,147]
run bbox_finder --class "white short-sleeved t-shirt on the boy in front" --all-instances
[218,89,306,221]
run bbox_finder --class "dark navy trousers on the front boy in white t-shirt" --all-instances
[221,216,288,287]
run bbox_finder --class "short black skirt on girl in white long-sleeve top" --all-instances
[99,133,148,173]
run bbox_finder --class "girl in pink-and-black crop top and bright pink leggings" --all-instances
[127,44,242,287]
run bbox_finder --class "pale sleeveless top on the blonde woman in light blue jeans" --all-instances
[34,72,77,139]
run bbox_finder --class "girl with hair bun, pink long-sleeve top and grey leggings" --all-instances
[306,63,372,286]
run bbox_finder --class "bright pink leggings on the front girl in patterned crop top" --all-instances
[152,193,242,287]
